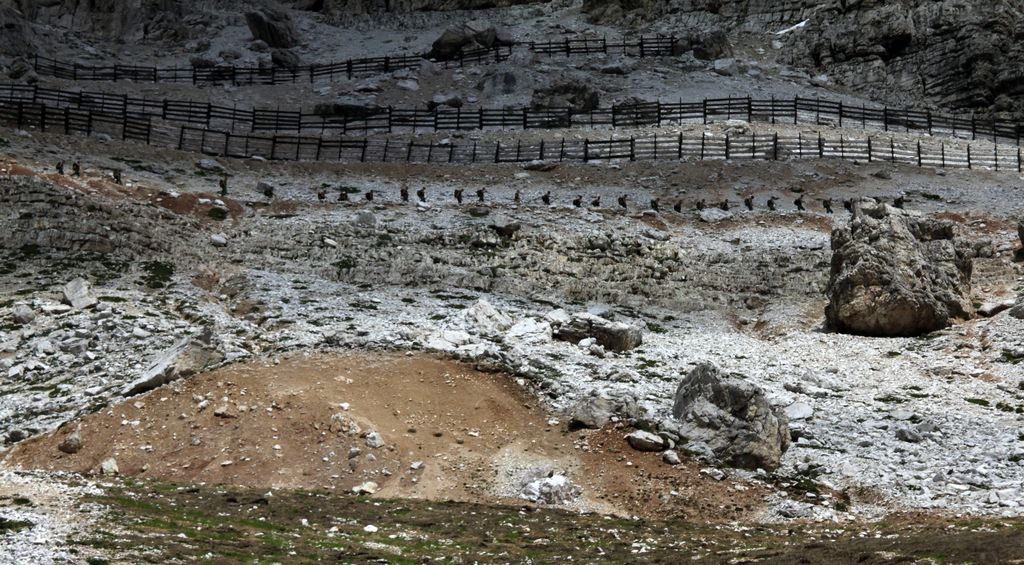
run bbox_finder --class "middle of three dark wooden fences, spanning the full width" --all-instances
[0,84,1022,145]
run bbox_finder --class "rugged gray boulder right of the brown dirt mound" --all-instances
[672,363,790,471]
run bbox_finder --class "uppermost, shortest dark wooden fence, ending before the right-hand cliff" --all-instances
[33,36,680,86]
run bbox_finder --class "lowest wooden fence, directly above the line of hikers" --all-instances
[0,100,1021,173]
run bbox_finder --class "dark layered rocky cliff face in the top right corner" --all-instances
[780,0,1024,112]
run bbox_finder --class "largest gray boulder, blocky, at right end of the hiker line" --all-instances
[825,200,973,337]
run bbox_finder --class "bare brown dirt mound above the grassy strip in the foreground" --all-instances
[6,352,764,521]
